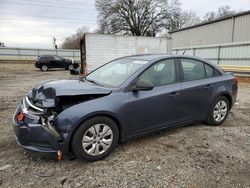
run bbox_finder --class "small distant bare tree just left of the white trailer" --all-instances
[62,26,89,49]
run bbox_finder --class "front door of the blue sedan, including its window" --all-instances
[126,59,180,135]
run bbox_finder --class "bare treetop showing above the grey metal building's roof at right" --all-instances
[203,5,236,21]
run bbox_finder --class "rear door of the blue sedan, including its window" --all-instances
[179,58,213,121]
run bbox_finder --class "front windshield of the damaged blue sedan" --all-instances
[86,59,147,87]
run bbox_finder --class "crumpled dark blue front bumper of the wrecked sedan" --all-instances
[12,97,65,154]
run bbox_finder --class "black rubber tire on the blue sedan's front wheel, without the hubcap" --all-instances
[71,116,119,161]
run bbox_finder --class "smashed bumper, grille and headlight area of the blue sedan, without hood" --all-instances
[13,96,63,156]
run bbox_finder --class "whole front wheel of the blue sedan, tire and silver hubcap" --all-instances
[72,116,119,161]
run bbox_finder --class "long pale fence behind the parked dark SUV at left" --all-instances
[0,47,80,61]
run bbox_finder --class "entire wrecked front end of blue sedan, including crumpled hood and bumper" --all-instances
[13,80,111,159]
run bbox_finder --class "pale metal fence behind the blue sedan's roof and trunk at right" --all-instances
[172,42,250,72]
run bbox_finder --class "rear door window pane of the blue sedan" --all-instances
[181,58,206,81]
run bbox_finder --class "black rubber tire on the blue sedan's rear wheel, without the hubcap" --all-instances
[206,96,230,126]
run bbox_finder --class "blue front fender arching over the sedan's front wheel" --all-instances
[55,96,126,152]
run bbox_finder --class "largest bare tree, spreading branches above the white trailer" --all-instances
[96,0,188,36]
